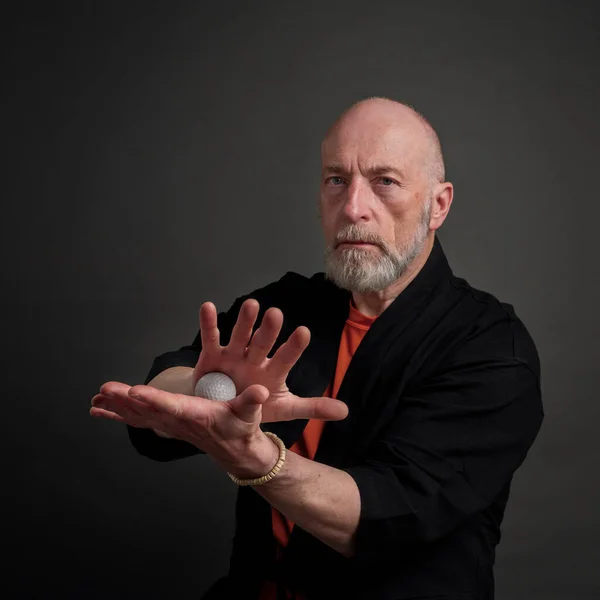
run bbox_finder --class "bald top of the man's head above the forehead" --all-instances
[321,97,445,185]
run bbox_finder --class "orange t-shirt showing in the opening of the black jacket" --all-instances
[259,300,377,600]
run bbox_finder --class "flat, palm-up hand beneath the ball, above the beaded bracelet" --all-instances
[90,381,279,478]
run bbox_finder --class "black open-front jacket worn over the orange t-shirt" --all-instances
[128,238,543,600]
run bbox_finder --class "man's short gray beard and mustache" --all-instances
[325,202,431,294]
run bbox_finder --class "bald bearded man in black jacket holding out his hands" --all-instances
[91,98,543,600]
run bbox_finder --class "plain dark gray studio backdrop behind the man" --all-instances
[1,0,600,600]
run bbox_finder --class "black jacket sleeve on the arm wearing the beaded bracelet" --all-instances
[344,356,543,560]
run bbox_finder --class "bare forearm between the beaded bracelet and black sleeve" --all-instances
[248,442,360,557]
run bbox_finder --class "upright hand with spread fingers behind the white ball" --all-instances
[193,299,348,423]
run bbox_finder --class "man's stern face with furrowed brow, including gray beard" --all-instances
[319,113,432,293]
